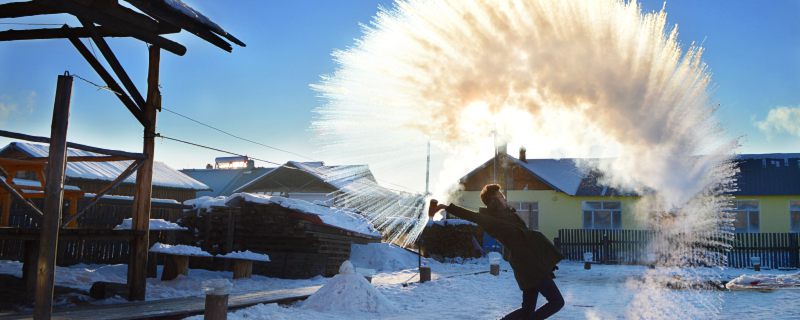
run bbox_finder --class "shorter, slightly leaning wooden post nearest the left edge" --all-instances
[33,75,72,319]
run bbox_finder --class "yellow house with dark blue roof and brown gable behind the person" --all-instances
[458,149,800,239]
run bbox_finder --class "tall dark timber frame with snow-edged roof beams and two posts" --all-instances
[0,0,244,319]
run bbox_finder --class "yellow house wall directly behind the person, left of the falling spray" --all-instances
[456,190,644,240]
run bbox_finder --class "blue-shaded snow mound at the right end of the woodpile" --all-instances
[350,243,419,272]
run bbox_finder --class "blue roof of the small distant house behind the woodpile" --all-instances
[181,168,275,197]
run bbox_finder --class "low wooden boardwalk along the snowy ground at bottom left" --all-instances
[0,286,320,320]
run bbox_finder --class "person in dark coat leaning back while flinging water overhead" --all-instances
[431,184,564,320]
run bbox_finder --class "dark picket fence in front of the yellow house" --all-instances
[554,229,800,268]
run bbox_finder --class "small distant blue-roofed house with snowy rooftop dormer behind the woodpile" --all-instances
[181,157,275,197]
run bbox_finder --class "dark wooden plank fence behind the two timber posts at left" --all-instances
[0,199,188,266]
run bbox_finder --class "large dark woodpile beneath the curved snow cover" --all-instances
[184,201,380,279]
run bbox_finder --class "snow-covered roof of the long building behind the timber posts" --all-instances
[0,142,210,202]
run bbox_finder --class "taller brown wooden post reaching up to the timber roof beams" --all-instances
[128,46,161,300]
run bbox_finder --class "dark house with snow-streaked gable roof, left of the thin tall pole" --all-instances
[233,161,396,208]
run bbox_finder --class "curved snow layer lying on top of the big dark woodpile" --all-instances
[184,192,381,237]
